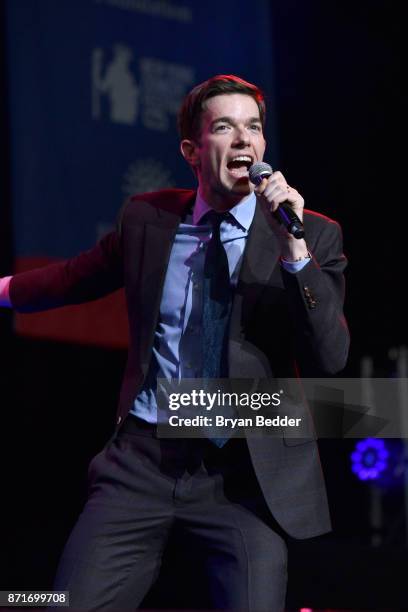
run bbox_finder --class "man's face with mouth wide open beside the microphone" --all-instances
[182,93,266,210]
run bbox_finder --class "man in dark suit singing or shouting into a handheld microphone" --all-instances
[2,75,349,612]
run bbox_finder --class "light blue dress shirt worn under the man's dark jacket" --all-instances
[130,193,309,423]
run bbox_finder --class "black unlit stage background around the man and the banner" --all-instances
[0,0,408,610]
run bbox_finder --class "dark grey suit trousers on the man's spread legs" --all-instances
[54,415,287,612]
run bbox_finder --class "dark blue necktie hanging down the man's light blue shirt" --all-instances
[202,211,233,447]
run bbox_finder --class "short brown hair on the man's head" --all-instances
[178,74,266,140]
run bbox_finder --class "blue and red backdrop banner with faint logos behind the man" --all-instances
[6,0,276,347]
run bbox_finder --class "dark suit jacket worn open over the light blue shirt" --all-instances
[10,189,349,538]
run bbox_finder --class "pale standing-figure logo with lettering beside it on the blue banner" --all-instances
[92,44,194,132]
